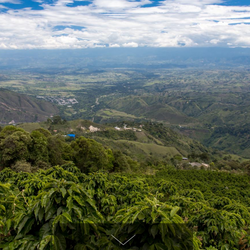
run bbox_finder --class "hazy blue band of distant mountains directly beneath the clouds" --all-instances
[0,47,250,73]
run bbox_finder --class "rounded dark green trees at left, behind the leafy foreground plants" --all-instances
[0,126,135,173]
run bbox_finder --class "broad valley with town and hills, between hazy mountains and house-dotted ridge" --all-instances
[1,68,250,158]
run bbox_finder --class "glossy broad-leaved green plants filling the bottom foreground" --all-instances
[0,164,250,250]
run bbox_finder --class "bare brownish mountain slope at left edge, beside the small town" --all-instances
[0,89,58,124]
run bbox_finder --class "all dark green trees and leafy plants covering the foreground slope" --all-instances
[0,122,250,250]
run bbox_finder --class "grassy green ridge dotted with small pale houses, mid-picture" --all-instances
[18,120,242,164]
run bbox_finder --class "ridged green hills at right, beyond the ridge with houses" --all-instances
[95,92,250,158]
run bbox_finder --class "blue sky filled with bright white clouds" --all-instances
[0,0,250,49]
